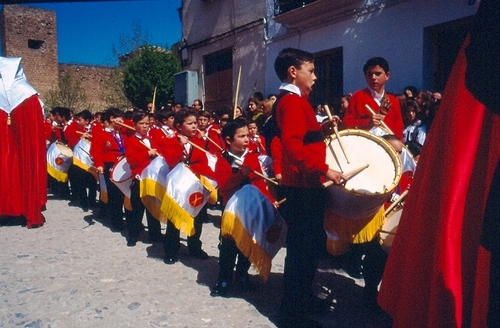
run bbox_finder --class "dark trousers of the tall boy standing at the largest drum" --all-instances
[279,187,326,315]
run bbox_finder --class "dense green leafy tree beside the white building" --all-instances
[123,46,181,108]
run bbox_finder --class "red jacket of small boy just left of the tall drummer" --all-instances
[215,152,275,205]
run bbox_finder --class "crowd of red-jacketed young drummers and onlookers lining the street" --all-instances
[41,48,440,327]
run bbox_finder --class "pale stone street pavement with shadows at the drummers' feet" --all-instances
[0,199,390,328]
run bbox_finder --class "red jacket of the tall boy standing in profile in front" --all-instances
[276,93,328,188]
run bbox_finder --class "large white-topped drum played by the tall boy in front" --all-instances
[326,129,402,220]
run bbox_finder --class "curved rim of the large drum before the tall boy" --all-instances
[325,129,403,196]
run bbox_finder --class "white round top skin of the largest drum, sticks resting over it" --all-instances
[326,129,401,194]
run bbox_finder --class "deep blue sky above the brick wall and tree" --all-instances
[26,0,182,66]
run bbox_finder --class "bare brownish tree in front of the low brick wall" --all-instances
[45,72,90,109]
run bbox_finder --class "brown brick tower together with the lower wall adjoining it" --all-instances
[0,5,121,111]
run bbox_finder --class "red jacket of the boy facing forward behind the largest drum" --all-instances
[344,88,404,138]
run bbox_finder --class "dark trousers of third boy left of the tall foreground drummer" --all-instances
[126,179,161,238]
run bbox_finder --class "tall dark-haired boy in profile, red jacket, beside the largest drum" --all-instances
[274,48,345,327]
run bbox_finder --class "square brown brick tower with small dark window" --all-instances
[0,5,59,99]
